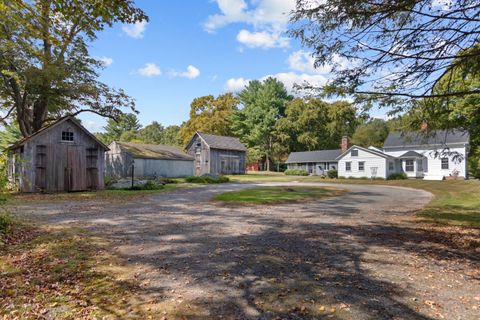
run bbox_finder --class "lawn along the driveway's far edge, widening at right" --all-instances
[230,173,480,228]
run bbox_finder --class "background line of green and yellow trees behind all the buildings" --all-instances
[0,78,480,177]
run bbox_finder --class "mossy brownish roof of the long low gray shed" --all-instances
[114,141,193,160]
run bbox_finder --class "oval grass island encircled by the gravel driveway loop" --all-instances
[214,187,342,204]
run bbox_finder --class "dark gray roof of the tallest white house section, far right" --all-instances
[384,129,470,148]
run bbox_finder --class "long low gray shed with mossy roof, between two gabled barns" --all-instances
[106,141,193,178]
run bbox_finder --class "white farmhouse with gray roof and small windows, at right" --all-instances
[337,130,470,180]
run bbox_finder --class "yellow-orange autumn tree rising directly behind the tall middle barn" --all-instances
[179,93,238,145]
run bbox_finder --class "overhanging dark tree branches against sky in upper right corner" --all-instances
[290,0,480,108]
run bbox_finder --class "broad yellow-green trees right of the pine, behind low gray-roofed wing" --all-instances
[276,99,358,154]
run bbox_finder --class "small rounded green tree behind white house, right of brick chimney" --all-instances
[351,119,389,148]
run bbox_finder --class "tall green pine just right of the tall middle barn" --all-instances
[232,78,292,170]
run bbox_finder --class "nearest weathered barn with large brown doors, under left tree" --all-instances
[7,117,108,192]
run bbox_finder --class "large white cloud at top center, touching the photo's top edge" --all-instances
[204,0,296,49]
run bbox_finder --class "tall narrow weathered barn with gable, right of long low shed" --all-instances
[187,132,247,176]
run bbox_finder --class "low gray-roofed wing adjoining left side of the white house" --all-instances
[285,149,342,175]
